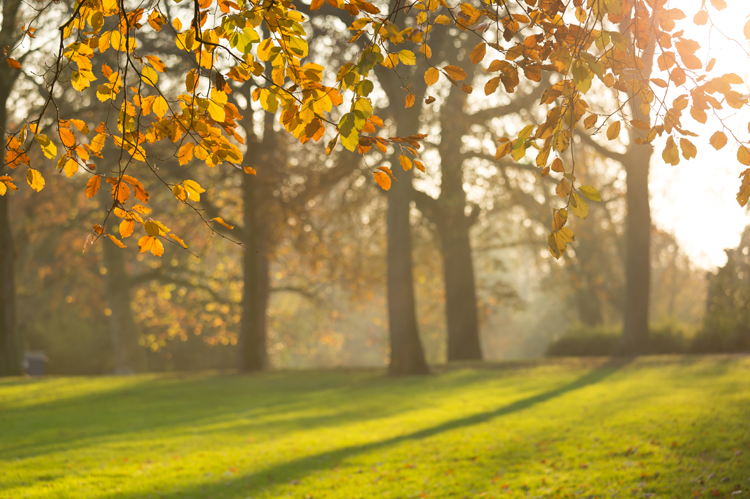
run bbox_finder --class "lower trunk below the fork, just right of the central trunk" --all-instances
[440,221,482,361]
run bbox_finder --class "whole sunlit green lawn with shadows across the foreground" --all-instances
[0,357,750,499]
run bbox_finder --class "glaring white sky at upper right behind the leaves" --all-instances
[650,0,750,268]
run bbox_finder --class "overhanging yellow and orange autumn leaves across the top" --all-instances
[0,0,750,258]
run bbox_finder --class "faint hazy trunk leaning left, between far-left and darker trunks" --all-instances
[101,221,147,374]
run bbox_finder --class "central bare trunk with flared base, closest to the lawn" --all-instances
[388,163,429,376]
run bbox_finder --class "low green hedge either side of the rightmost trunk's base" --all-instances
[545,322,689,357]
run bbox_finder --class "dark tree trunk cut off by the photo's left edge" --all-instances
[0,94,23,376]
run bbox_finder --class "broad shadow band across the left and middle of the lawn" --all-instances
[0,371,528,462]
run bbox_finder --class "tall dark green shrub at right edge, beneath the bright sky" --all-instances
[704,227,750,352]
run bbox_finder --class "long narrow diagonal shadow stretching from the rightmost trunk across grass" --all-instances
[101,358,632,499]
